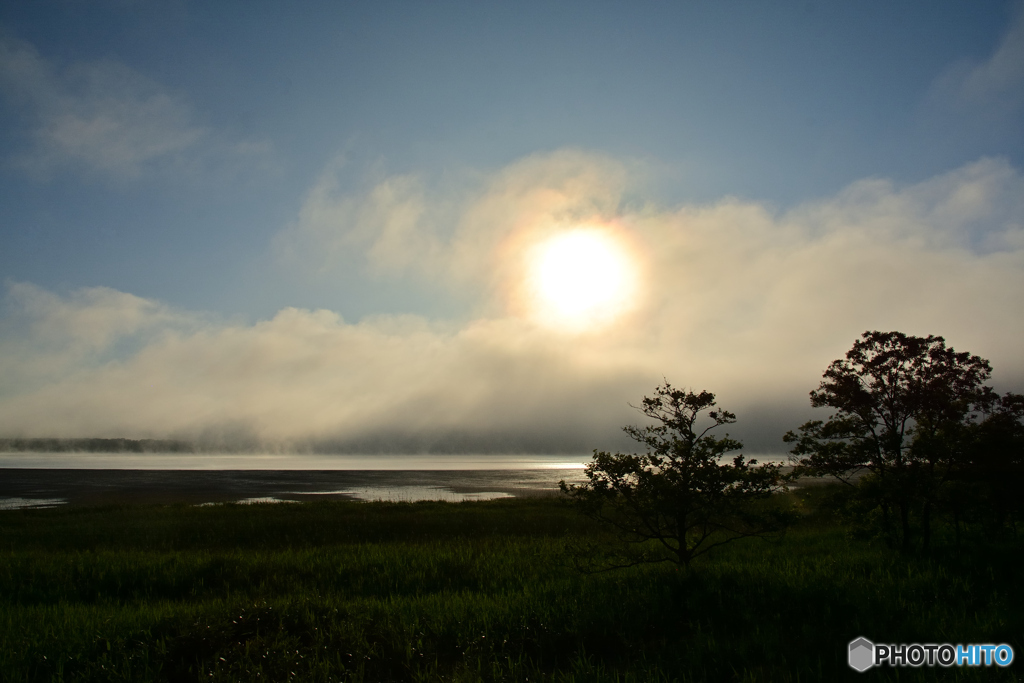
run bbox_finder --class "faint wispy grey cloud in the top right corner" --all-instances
[932,2,1024,125]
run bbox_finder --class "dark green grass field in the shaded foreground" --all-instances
[0,490,1024,682]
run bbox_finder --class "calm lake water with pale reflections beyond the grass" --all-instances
[0,453,590,510]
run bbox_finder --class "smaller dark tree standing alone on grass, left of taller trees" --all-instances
[561,382,786,568]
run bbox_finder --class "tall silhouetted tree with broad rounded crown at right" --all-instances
[784,332,1014,550]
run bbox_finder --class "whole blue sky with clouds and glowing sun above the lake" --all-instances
[0,0,1024,454]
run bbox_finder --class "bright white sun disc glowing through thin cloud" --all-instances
[527,227,637,332]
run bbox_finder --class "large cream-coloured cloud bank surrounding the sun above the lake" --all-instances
[0,152,1024,452]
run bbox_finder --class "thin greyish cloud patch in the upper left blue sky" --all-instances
[0,38,267,178]
